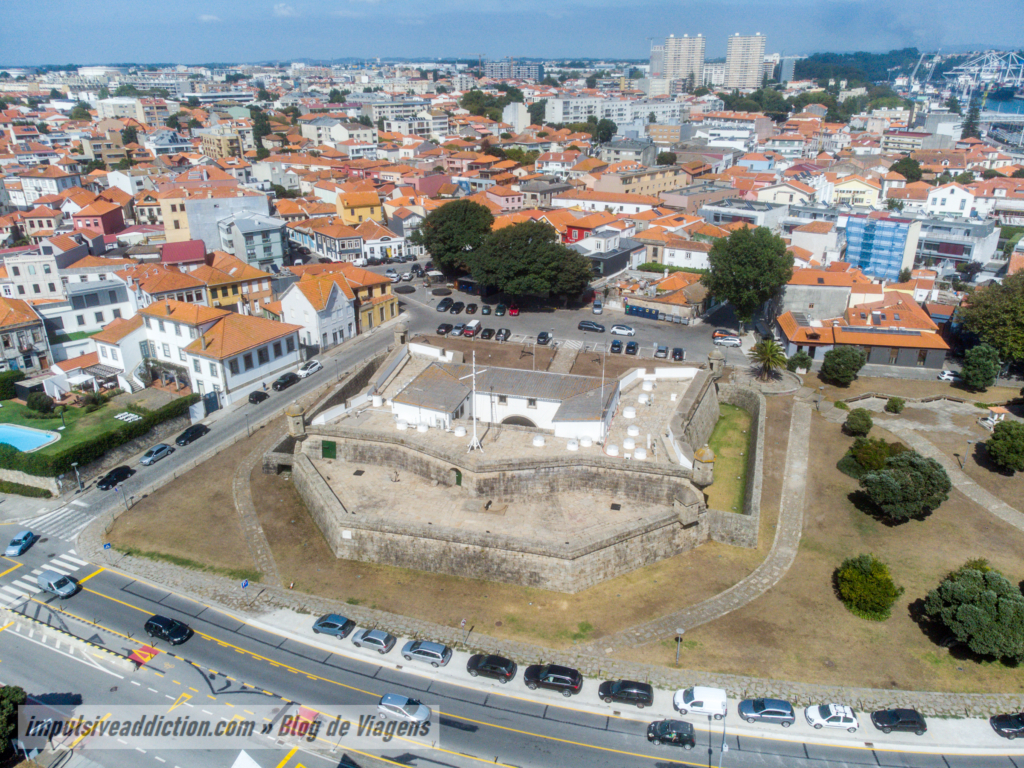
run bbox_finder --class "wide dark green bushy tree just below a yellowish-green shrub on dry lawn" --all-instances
[860,451,952,522]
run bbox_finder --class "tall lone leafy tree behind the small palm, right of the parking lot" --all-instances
[700,226,793,322]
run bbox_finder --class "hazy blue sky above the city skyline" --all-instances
[0,0,1024,66]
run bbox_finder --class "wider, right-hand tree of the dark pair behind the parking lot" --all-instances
[466,222,592,297]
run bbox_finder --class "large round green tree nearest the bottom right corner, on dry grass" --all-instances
[925,561,1024,664]
